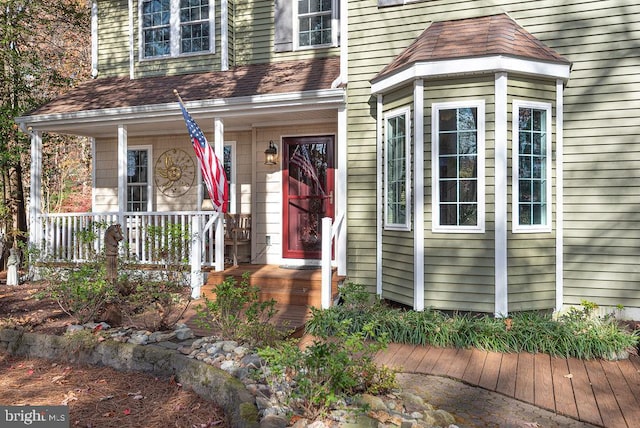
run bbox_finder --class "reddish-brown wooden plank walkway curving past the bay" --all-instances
[376,344,640,428]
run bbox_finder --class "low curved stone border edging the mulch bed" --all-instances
[0,329,259,428]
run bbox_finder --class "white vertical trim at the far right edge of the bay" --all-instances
[556,79,564,310]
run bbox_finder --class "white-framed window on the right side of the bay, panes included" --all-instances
[512,101,551,232]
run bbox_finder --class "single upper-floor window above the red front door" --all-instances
[298,0,333,47]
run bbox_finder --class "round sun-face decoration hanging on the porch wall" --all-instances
[155,149,196,198]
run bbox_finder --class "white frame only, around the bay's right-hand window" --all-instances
[511,100,553,233]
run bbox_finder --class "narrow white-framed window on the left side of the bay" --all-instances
[384,109,411,230]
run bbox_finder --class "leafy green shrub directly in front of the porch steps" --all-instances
[197,272,286,346]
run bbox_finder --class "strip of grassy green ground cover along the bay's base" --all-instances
[307,284,640,359]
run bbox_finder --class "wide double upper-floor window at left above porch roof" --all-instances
[140,0,214,58]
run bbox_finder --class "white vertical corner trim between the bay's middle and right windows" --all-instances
[494,72,509,317]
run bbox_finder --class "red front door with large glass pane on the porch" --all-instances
[282,135,334,259]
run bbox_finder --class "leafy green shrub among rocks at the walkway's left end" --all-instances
[259,320,397,419]
